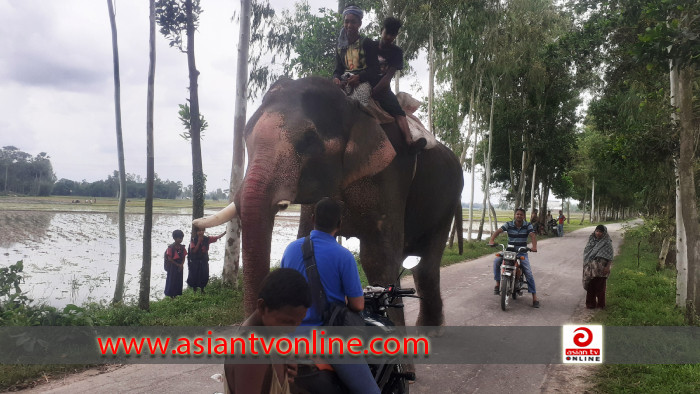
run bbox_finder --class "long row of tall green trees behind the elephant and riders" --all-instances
[245,0,700,316]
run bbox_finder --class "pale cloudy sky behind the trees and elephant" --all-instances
[0,0,496,203]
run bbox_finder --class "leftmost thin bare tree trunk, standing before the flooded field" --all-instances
[107,0,126,304]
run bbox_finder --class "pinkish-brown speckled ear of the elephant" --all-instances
[343,110,396,187]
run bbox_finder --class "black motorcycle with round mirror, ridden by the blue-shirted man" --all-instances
[292,256,420,394]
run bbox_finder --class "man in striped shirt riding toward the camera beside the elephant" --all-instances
[489,208,540,308]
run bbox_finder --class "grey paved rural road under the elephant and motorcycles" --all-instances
[25,224,621,394]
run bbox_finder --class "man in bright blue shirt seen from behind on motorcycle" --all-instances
[280,197,379,394]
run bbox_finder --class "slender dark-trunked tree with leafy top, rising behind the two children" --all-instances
[156,0,206,219]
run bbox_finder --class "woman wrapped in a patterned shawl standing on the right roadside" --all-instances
[583,224,613,309]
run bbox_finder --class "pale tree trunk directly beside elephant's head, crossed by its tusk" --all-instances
[221,0,251,286]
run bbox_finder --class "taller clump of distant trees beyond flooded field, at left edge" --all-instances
[0,146,56,196]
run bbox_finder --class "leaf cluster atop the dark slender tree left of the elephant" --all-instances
[156,0,202,53]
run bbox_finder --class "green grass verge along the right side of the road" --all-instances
[592,222,700,393]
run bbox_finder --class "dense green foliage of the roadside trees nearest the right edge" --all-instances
[567,0,700,216]
